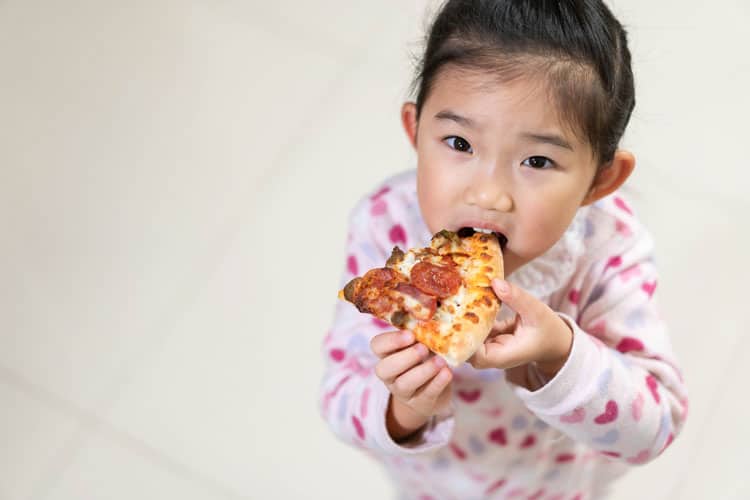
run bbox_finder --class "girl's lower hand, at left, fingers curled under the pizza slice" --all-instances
[370,331,453,438]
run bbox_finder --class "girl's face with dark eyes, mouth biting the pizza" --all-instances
[402,69,596,275]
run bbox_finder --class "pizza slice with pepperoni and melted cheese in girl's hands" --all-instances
[339,228,503,367]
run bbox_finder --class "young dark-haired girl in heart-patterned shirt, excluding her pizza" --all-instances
[321,0,687,500]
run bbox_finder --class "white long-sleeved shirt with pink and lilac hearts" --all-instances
[320,171,687,500]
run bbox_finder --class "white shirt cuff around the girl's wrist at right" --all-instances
[514,313,604,415]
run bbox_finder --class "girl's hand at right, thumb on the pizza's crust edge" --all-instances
[469,279,573,378]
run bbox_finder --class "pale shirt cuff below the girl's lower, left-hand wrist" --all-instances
[373,378,455,455]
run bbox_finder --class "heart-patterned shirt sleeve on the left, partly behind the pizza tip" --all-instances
[320,188,454,455]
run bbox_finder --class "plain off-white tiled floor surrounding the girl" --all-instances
[0,0,750,500]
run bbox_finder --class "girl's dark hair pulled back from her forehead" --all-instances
[411,0,635,166]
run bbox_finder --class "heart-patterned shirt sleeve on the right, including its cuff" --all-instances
[516,219,687,464]
